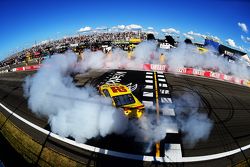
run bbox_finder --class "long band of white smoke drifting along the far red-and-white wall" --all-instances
[74,41,250,79]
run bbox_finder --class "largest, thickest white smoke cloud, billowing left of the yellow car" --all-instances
[24,53,127,142]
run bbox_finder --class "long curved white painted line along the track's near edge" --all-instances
[0,100,250,162]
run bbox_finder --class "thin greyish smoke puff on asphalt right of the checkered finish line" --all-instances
[174,93,213,147]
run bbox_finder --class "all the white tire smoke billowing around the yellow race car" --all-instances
[24,38,250,150]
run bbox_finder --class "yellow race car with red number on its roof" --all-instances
[99,84,145,119]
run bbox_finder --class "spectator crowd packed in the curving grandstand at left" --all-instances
[0,31,147,68]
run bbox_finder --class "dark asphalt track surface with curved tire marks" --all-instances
[0,70,250,166]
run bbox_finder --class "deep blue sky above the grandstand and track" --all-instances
[0,0,250,60]
